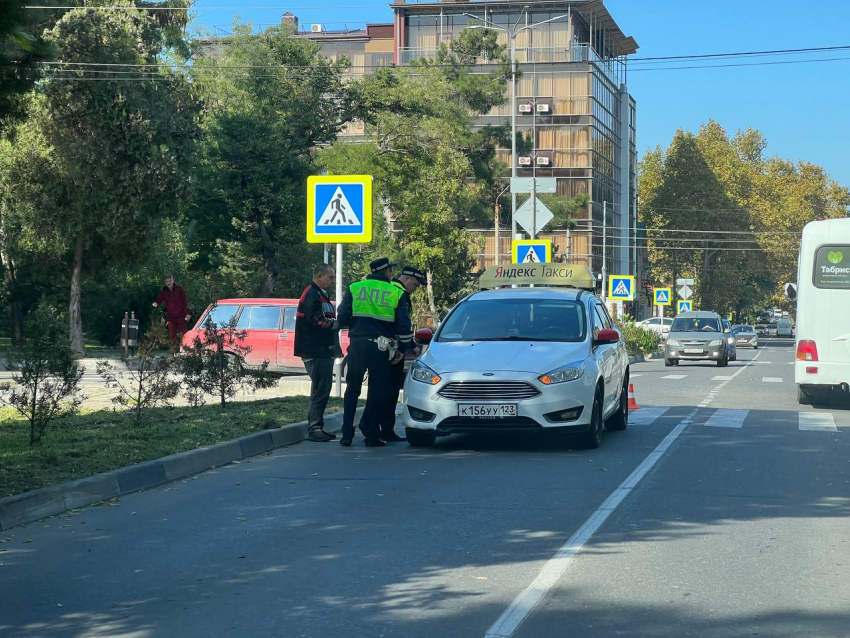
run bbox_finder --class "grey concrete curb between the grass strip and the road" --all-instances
[0,408,363,530]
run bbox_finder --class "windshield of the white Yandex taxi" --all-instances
[437,297,587,342]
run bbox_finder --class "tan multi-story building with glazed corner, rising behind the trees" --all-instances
[199,0,638,274]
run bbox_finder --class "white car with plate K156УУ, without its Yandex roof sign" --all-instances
[404,287,629,448]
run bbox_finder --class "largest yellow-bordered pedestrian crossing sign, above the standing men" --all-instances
[307,175,372,244]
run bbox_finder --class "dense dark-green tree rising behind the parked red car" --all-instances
[189,24,351,297]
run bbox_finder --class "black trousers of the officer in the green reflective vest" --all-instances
[342,339,390,440]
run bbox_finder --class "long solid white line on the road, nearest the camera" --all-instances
[484,410,697,638]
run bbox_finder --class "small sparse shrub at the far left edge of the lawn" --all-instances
[0,307,85,445]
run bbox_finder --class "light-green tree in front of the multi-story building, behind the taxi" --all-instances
[321,30,511,315]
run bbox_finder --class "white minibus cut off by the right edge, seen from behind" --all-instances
[786,219,850,404]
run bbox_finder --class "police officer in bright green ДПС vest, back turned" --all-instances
[338,257,413,447]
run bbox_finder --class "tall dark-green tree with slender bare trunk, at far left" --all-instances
[28,3,197,352]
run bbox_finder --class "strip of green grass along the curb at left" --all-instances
[0,396,342,497]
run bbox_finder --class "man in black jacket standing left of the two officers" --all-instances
[295,264,341,443]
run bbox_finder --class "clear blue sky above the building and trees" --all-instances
[189,0,850,186]
